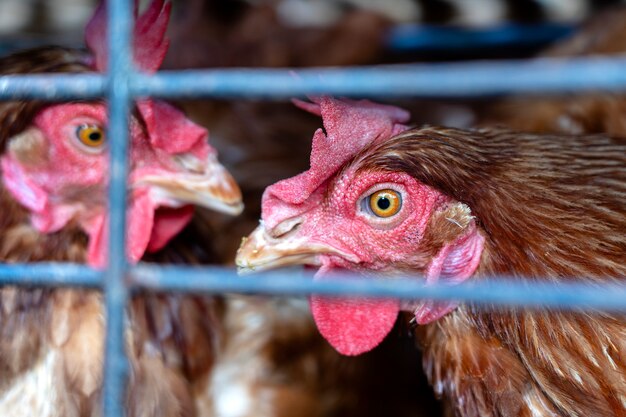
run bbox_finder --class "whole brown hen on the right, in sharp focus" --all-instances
[237,97,626,416]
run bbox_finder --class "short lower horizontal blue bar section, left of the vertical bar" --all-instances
[0,262,103,288]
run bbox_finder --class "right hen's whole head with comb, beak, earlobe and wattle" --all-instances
[237,98,483,355]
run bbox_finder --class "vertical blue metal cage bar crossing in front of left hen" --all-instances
[103,0,133,417]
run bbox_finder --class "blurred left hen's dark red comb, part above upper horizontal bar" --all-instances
[85,0,172,72]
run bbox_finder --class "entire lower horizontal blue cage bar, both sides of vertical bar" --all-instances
[0,263,626,311]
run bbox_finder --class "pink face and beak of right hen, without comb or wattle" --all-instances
[242,167,440,272]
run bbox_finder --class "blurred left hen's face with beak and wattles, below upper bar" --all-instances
[1,101,242,266]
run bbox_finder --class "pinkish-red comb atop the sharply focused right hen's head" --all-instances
[263,97,409,223]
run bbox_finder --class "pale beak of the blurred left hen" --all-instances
[137,155,243,215]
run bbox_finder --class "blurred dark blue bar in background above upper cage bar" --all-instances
[387,23,576,52]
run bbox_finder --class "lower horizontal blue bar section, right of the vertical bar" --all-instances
[131,264,626,311]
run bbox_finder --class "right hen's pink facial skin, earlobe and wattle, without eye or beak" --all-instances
[263,166,483,355]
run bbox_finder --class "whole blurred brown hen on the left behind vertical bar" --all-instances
[0,0,242,417]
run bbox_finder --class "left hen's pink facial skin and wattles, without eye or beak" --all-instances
[1,102,215,266]
